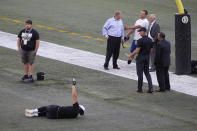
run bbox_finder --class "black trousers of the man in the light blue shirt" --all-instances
[104,36,121,67]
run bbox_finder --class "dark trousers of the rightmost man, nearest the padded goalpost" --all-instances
[156,66,170,90]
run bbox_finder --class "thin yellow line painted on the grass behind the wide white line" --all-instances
[0,17,130,48]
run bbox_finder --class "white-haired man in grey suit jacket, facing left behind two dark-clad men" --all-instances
[148,14,160,72]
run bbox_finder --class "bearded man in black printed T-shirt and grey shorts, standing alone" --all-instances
[17,20,40,82]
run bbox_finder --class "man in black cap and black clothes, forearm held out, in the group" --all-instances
[129,27,153,93]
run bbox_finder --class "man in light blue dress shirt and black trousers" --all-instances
[103,11,124,70]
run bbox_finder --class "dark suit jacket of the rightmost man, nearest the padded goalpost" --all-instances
[155,40,171,67]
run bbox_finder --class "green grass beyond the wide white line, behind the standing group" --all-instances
[0,0,197,69]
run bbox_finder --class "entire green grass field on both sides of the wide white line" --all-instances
[0,0,197,131]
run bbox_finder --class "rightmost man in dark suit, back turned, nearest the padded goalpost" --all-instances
[155,32,171,92]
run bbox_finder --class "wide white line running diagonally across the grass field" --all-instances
[0,31,197,96]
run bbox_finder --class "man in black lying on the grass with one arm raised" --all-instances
[25,78,85,119]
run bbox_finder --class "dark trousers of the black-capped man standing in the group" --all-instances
[136,55,153,90]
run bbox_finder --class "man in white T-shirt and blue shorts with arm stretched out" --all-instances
[125,10,149,53]
